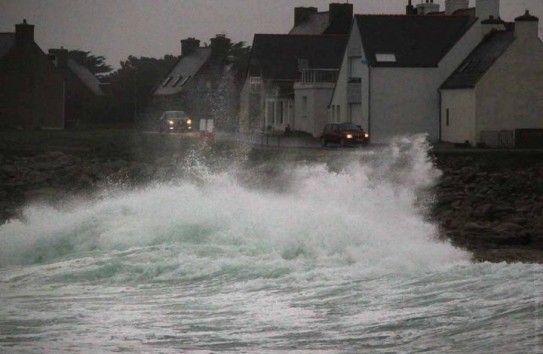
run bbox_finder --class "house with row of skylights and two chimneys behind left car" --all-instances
[139,34,239,129]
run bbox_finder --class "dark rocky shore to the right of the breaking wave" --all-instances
[432,150,543,263]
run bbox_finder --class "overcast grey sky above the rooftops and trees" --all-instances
[0,0,543,68]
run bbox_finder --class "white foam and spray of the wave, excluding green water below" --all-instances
[0,137,467,271]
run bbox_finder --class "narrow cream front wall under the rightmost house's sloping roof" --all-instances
[441,89,477,145]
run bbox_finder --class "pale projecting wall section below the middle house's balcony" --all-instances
[292,82,334,137]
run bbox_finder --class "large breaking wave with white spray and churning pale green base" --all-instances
[0,136,469,280]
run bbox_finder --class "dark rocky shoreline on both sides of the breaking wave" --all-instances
[0,145,543,263]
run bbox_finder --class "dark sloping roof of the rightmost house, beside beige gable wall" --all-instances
[440,31,515,89]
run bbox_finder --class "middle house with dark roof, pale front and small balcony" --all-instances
[240,34,347,136]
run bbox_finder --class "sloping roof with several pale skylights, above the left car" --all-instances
[154,47,211,95]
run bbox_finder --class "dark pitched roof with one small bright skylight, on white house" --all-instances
[355,15,475,67]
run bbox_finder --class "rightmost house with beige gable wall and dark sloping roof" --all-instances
[440,11,543,148]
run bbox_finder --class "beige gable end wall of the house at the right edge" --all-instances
[476,35,543,134]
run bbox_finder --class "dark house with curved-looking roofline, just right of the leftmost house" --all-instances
[49,48,108,127]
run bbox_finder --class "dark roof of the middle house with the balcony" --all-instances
[249,34,347,80]
